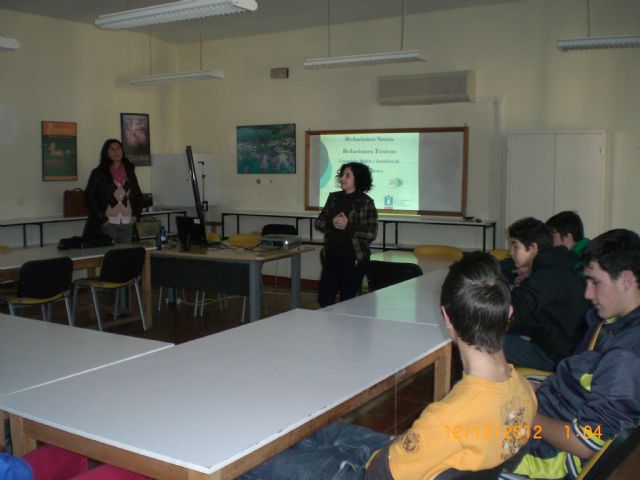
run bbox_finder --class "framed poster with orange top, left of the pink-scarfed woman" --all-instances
[42,122,78,182]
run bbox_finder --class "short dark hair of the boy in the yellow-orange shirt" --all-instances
[440,252,511,353]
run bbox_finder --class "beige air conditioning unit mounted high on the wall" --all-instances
[377,70,476,105]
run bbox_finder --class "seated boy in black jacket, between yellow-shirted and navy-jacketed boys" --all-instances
[504,217,590,371]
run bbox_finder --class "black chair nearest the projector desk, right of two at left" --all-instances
[73,247,148,330]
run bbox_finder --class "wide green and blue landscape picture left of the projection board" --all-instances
[237,123,296,173]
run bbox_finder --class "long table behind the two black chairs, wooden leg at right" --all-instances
[0,241,156,328]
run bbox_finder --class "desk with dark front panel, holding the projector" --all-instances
[150,245,313,322]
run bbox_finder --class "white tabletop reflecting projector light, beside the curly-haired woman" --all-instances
[323,270,448,332]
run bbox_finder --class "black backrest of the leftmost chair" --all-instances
[18,257,73,299]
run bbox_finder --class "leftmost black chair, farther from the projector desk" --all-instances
[0,257,73,325]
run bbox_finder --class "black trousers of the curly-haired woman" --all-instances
[318,254,369,307]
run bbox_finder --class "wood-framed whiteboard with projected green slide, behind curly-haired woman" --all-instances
[306,127,468,214]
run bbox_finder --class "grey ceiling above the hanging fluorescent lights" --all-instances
[0,0,522,43]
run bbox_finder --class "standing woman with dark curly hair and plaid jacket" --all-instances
[315,162,378,307]
